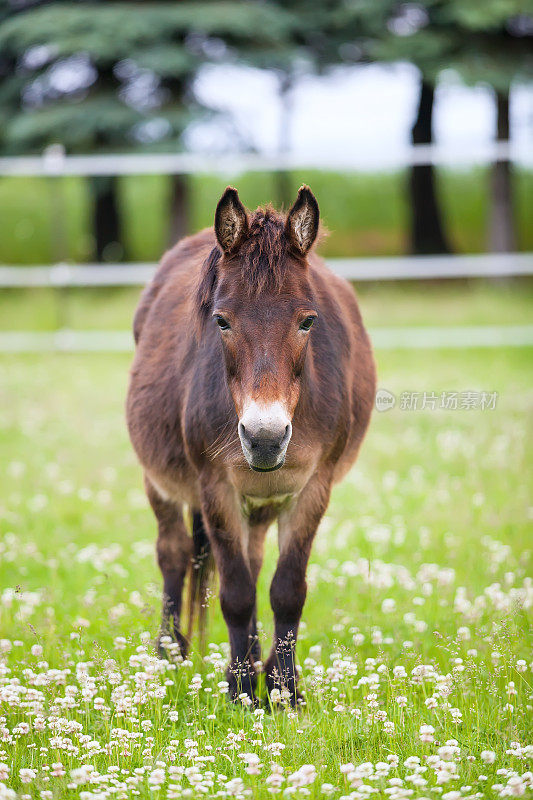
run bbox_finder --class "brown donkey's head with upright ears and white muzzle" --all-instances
[199,186,319,472]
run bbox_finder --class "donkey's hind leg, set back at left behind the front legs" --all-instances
[145,478,192,657]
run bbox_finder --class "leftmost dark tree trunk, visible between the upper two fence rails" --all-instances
[89,176,124,262]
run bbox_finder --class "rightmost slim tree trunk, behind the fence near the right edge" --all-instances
[489,91,516,253]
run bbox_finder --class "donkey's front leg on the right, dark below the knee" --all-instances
[264,476,330,705]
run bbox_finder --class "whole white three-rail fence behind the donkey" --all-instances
[0,142,533,353]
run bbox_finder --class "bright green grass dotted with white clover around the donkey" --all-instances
[0,284,533,800]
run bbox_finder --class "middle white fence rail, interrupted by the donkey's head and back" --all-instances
[0,253,533,288]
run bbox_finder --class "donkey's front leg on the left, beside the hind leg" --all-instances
[202,484,256,700]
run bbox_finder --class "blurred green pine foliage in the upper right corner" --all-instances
[280,0,533,90]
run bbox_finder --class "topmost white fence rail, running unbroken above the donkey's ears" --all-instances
[0,141,533,176]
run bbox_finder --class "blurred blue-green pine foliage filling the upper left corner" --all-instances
[0,0,293,153]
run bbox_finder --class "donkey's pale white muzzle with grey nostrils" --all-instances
[239,414,292,472]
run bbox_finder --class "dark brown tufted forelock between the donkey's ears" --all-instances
[238,206,287,294]
